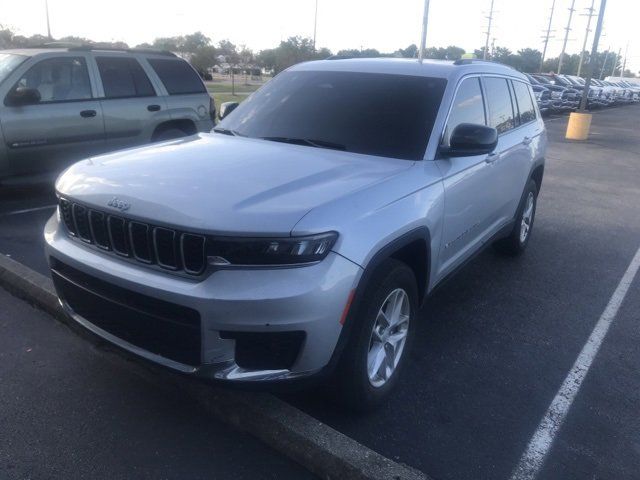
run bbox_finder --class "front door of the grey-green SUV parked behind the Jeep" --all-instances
[0,54,104,175]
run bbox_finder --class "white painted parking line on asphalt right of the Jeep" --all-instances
[511,248,640,480]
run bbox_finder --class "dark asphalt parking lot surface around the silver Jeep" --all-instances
[0,106,640,479]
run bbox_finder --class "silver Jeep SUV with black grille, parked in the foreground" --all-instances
[45,59,547,407]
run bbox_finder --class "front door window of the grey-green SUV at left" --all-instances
[14,57,91,103]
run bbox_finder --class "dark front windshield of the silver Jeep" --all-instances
[216,71,446,160]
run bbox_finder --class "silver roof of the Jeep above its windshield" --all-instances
[291,57,527,81]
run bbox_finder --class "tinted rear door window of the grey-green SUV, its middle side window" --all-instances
[96,57,156,98]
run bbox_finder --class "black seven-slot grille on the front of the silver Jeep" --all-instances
[59,198,206,275]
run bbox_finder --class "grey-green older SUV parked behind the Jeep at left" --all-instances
[0,47,215,182]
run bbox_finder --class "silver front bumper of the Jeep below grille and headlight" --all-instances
[44,215,362,381]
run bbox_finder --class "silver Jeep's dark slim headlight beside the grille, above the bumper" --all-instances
[207,232,338,266]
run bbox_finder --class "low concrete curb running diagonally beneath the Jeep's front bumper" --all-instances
[0,255,429,480]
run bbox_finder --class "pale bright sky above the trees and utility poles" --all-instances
[0,0,640,72]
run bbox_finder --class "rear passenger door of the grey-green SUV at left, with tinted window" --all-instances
[95,54,170,150]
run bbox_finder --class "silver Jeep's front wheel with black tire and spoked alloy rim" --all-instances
[335,259,418,411]
